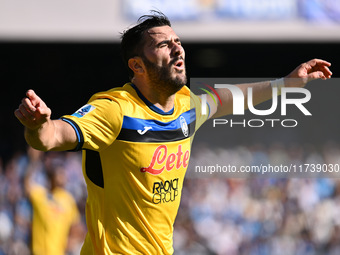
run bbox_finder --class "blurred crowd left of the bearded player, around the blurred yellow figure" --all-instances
[0,147,87,255]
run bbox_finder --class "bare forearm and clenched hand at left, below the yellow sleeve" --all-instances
[14,90,77,151]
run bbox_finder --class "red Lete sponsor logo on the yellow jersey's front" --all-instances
[140,144,190,175]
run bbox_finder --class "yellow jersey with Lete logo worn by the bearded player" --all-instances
[62,83,207,255]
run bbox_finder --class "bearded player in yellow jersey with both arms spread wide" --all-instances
[15,10,331,254]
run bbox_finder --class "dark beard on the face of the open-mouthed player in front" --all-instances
[142,56,187,95]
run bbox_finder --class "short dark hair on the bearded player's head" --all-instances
[120,10,171,79]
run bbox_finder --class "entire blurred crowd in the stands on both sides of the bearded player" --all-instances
[0,144,340,255]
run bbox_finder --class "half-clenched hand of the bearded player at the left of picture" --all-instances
[14,90,51,130]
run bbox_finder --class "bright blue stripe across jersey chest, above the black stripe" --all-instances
[122,109,196,131]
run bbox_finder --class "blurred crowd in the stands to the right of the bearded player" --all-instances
[174,143,340,255]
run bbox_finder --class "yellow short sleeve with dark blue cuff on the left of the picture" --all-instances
[61,98,123,151]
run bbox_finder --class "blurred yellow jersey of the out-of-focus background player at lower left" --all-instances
[29,185,80,255]
